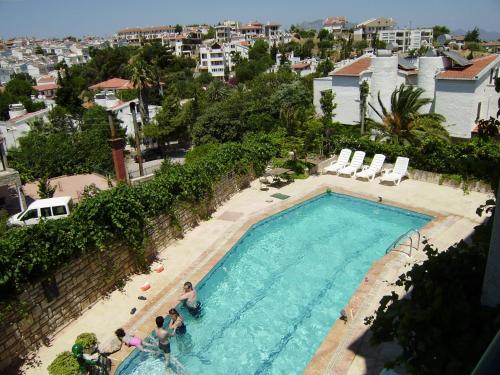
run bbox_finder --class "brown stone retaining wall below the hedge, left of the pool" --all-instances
[0,175,254,370]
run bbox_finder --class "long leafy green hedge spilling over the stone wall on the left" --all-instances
[0,135,278,299]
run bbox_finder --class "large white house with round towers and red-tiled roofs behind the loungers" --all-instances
[314,52,500,138]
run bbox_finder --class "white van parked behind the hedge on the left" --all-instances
[7,197,73,226]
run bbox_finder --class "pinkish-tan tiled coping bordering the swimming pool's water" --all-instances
[109,184,450,375]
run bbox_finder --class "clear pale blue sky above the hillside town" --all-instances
[0,0,500,38]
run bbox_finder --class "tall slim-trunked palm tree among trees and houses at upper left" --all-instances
[129,54,156,124]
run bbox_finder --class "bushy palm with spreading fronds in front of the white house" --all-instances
[367,84,449,145]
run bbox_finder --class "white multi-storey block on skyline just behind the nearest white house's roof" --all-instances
[377,29,434,52]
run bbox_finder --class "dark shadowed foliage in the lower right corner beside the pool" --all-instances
[366,210,500,375]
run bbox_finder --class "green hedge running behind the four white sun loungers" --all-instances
[330,135,500,188]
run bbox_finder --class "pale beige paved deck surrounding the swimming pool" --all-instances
[23,175,490,375]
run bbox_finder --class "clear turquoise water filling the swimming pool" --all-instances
[117,194,432,375]
